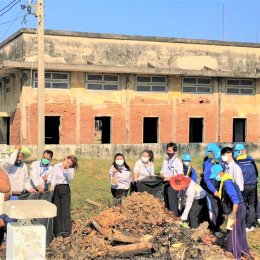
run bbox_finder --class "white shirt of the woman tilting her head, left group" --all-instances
[51,162,74,186]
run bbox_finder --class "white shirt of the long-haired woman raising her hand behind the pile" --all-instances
[109,165,132,190]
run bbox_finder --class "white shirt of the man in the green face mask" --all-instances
[30,160,52,189]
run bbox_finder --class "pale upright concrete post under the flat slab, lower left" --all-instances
[6,223,46,260]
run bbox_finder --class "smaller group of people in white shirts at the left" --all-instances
[0,145,78,243]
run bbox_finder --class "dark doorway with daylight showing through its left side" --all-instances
[95,116,111,144]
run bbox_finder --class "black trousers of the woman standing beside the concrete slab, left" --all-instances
[53,184,72,237]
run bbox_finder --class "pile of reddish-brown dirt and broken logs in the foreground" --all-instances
[47,193,232,259]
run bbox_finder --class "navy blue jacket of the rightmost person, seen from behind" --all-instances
[235,156,258,185]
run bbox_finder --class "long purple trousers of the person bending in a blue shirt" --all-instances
[227,203,250,259]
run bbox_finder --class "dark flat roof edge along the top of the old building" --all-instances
[0,28,260,48]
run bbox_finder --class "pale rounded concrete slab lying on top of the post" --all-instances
[3,200,57,219]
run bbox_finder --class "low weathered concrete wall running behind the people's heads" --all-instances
[0,143,260,160]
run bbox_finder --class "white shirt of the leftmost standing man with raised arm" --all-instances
[2,150,32,192]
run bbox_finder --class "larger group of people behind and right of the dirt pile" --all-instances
[109,143,260,259]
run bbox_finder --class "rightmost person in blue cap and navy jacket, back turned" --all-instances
[234,144,260,232]
